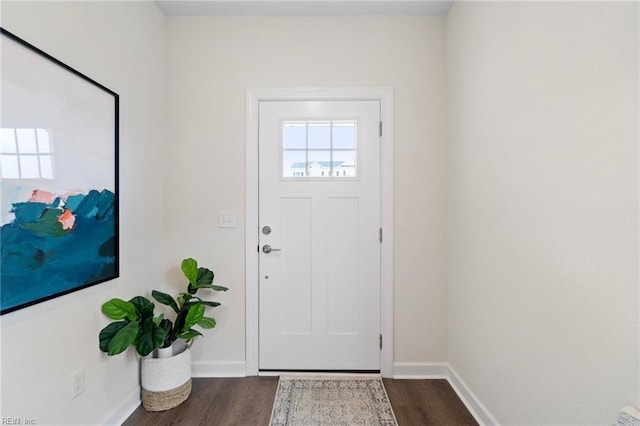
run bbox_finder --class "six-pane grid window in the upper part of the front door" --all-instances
[282,120,358,179]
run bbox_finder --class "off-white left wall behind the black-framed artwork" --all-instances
[1,1,165,425]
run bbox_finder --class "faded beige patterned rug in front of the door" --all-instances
[269,376,398,426]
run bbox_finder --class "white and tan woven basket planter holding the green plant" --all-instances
[140,345,191,411]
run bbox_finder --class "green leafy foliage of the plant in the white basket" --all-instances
[99,258,228,356]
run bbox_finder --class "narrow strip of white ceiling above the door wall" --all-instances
[156,0,453,16]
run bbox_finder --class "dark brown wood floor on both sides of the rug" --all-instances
[124,377,478,426]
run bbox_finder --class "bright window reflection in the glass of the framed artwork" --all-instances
[0,128,54,179]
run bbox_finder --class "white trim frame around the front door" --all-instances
[245,87,393,377]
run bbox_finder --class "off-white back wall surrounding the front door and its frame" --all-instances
[166,17,447,371]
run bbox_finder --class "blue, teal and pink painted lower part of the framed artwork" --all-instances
[0,189,118,314]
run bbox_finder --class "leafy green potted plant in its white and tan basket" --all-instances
[99,258,228,411]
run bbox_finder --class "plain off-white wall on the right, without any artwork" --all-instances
[447,2,639,425]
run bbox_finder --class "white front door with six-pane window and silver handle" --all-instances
[258,101,380,371]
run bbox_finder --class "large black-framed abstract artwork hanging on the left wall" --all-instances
[0,28,119,314]
